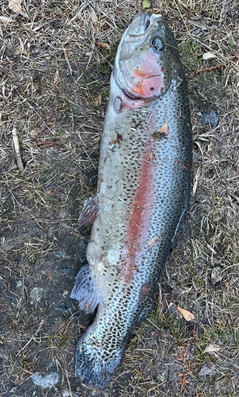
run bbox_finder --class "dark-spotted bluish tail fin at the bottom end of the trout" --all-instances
[75,326,126,390]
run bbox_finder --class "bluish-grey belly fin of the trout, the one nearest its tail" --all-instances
[71,265,99,313]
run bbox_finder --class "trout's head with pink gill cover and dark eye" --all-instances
[113,13,181,100]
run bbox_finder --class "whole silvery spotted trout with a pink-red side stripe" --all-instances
[71,13,192,390]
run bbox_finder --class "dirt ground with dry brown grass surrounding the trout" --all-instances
[0,0,239,397]
